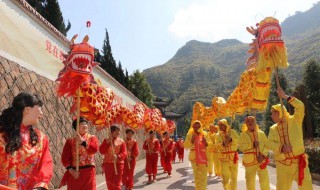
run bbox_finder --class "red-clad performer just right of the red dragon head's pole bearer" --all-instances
[99,125,127,190]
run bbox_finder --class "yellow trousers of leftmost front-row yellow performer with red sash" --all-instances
[191,162,208,190]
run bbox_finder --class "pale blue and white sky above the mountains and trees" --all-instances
[58,0,319,74]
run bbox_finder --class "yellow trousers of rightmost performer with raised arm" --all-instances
[276,162,313,190]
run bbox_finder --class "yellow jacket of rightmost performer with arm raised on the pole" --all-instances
[266,98,305,163]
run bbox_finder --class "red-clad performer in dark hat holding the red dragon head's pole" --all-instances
[60,117,99,189]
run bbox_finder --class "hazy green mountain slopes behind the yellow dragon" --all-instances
[143,3,320,113]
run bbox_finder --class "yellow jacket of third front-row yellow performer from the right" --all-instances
[215,129,239,162]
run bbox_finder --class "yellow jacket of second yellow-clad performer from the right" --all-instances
[239,130,268,166]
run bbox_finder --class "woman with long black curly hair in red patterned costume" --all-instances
[0,93,53,190]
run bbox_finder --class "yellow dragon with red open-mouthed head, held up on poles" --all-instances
[192,17,289,128]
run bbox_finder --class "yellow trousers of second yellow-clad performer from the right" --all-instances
[245,164,270,190]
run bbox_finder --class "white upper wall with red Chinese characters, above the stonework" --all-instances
[0,0,139,108]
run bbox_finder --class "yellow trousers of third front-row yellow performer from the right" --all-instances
[221,161,238,190]
